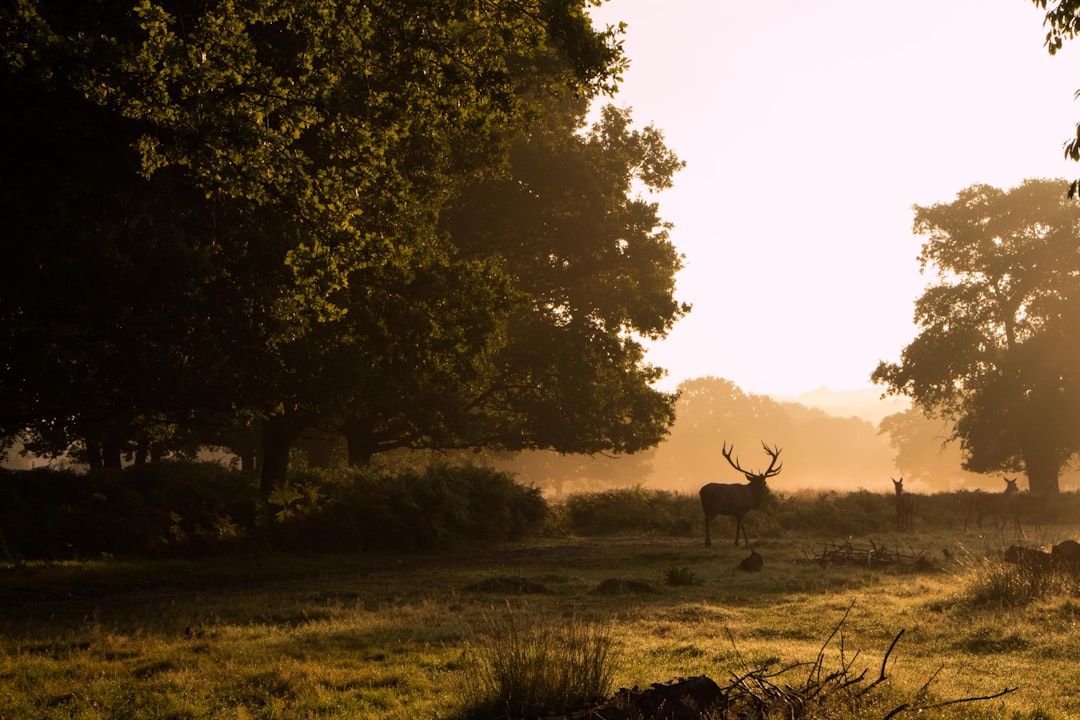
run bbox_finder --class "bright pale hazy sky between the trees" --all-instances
[593,0,1080,395]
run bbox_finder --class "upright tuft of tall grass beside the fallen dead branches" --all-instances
[467,606,619,718]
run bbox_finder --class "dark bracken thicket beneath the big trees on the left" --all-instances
[0,463,548,560]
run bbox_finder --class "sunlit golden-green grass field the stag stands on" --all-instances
[0,505,1080,720]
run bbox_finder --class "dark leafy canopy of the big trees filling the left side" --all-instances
[0,0,688,487]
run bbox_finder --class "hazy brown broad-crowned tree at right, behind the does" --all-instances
[872,180,1080,493]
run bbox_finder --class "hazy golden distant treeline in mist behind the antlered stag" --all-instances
[489,378,1036,497]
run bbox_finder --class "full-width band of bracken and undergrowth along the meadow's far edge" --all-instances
[8,463,1080,562]
